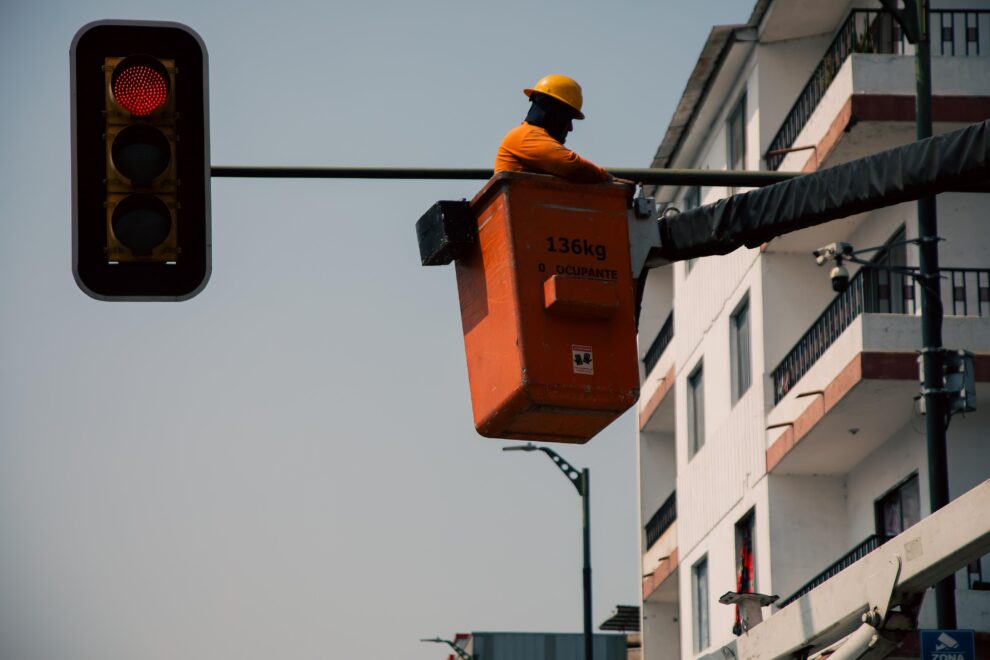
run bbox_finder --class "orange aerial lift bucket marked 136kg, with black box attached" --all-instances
[417,172,639,443]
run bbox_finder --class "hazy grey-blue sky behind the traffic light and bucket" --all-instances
[0,0,752,660]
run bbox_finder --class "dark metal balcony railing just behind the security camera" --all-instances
[773,268,990,404]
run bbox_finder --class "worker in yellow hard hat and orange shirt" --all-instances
[495,74,632,184]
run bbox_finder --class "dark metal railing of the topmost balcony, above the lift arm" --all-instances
[765,9,990,170]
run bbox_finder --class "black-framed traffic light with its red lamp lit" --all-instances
[71,21,210,300]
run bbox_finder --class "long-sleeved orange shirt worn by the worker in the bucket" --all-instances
[495,122,611,183]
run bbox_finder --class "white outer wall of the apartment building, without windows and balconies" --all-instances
[639,0,990,660]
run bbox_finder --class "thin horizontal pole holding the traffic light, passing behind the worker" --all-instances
[210,165,801,187]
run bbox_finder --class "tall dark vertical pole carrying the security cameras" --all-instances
[881,0,956,629]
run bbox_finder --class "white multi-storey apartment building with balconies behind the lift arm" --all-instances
[639,0,990,660]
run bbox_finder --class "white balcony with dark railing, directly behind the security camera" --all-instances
[766,268,990,476]
